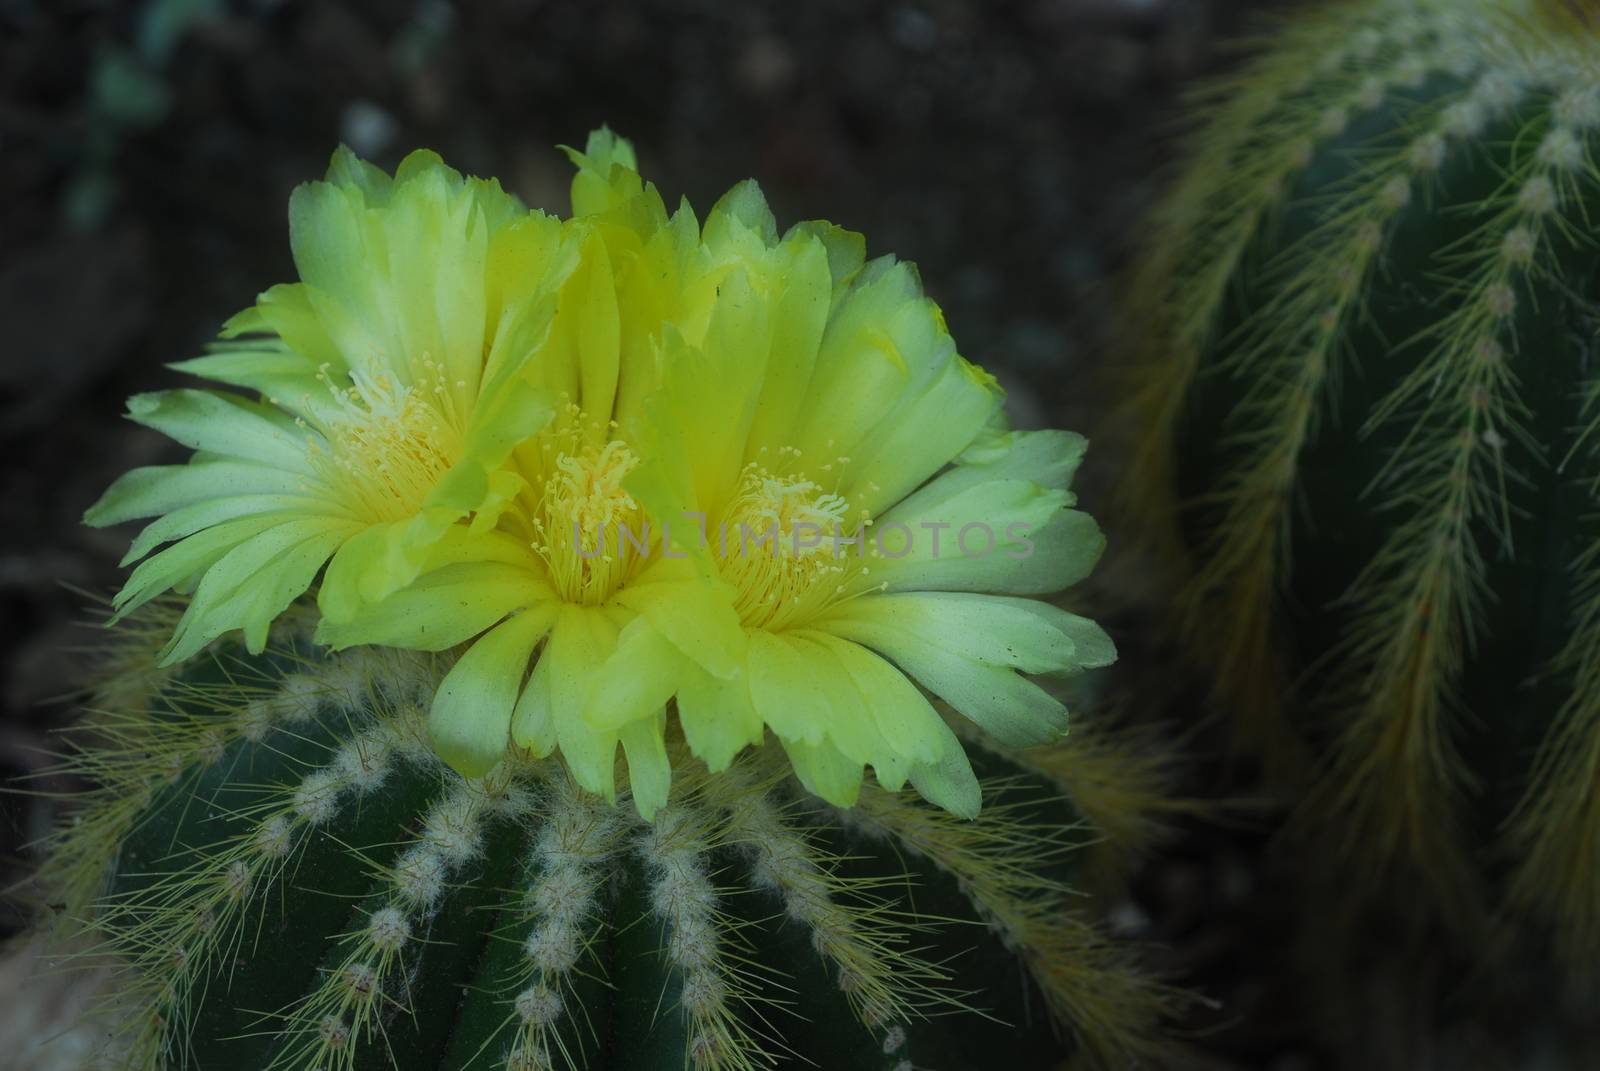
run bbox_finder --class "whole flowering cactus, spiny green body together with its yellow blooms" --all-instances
[21,131,1165,1071]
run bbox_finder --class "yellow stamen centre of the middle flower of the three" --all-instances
[523,407,656,605]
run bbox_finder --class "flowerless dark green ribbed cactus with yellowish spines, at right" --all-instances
[1130,0,1600,967]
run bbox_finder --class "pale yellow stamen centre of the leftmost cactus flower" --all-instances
[312,367,461,520]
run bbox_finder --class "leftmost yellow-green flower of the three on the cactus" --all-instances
[85,147,576,664]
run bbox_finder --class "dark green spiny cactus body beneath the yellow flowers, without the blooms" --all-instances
[37,608,1168,1071]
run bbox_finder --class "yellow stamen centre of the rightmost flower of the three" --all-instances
[717,458,872,631]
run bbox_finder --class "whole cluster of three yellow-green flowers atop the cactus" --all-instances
[86,130,1114,816]
